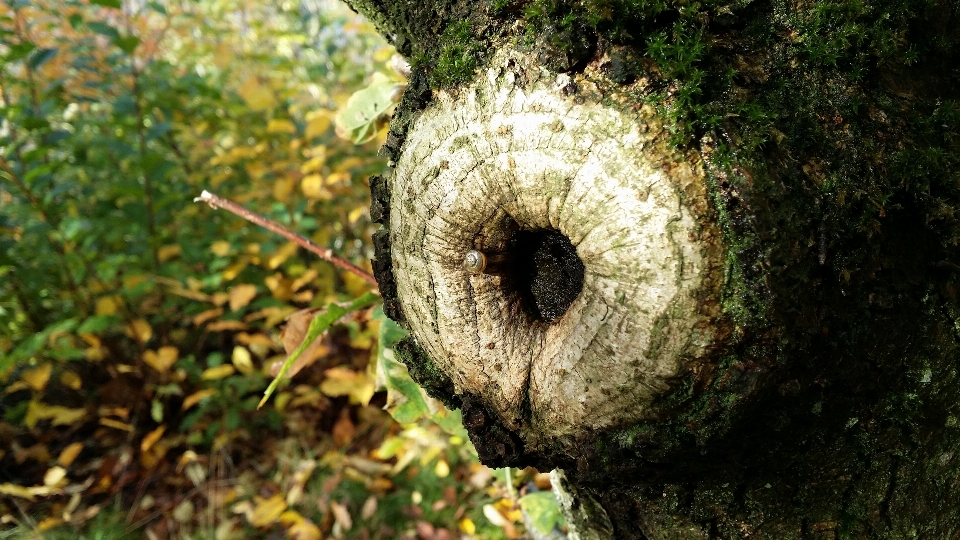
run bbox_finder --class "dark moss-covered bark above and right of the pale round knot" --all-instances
[362,0,960,538]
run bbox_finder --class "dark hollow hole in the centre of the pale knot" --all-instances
[510,229,583,322]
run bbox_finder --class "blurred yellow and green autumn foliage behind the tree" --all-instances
[0,0,549,540]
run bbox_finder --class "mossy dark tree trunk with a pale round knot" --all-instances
[351,0,960,539]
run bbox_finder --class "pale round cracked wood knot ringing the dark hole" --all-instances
[389,49,722,447]
